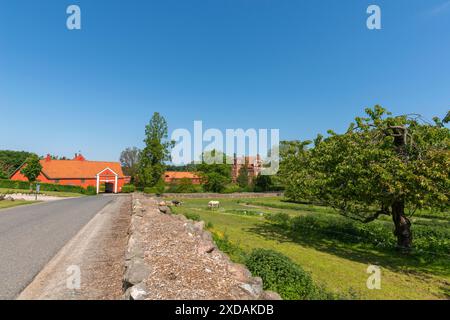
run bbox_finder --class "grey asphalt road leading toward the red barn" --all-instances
[0,195,115,299]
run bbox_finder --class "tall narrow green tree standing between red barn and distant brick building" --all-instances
[137,112,173,187]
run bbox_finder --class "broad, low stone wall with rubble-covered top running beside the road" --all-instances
[123,194,281,300]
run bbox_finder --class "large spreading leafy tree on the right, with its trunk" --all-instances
[281,106,450,249]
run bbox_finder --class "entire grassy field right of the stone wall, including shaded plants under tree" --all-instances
[174,198,450,299]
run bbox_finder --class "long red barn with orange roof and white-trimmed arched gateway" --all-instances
[11,154,130,193]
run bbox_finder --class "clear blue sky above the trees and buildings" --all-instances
[0,0,450,160]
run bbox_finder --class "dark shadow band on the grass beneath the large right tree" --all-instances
[246,222,450,279]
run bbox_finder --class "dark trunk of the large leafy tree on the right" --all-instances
[392,200,412,251]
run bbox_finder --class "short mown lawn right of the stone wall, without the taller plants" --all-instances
[174,198,450,299]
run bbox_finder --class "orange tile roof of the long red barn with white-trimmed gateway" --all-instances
[40,159,124,179]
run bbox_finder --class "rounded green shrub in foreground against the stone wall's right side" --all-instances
[246,249,321,300]
